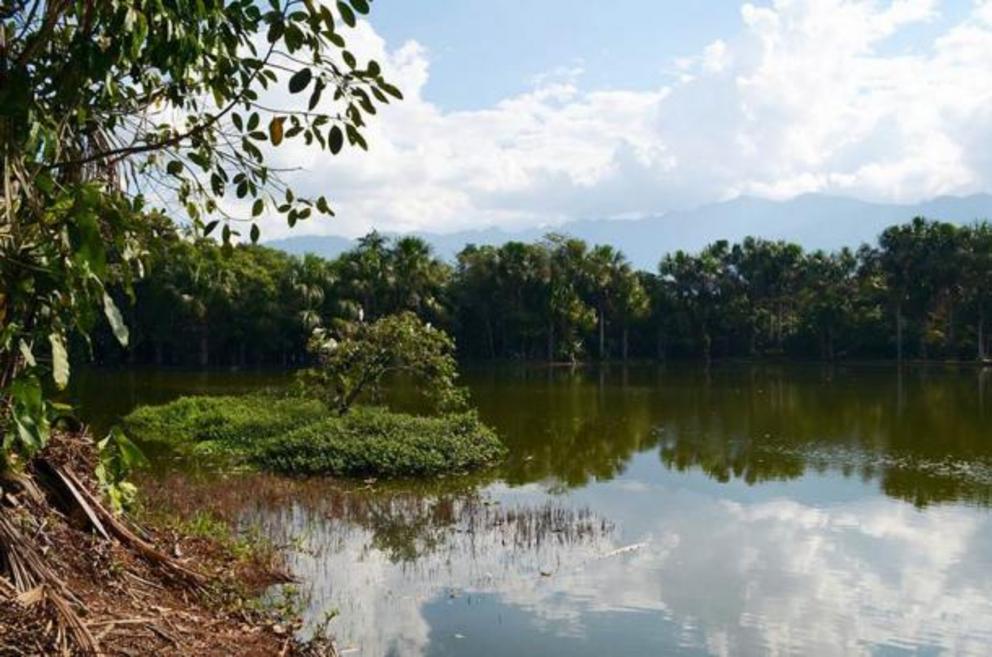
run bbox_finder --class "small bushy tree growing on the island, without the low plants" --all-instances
[308,312,467,415]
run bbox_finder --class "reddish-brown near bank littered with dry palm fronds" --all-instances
[0,433,333,657]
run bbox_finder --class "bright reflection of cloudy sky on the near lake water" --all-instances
[256,476,992,657]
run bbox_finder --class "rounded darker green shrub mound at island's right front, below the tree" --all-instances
[253,408,505,477]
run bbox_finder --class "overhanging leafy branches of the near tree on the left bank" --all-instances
[0,0,402,467]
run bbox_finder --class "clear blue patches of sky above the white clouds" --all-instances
[364,0,971,110]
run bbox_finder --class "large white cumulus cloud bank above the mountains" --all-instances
[254,0,992,236]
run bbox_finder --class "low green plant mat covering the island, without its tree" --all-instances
[124,395,505,477]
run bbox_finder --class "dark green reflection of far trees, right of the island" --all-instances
[462,365,992,507]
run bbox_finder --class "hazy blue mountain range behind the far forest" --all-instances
[268,194,992,270]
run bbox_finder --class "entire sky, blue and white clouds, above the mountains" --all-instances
[250,0,992,238]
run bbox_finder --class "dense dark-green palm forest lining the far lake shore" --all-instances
[92,218,992,366]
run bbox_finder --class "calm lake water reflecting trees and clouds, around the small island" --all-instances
[71,366,992,657]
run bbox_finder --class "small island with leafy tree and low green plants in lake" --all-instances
[124,313,506,477]
